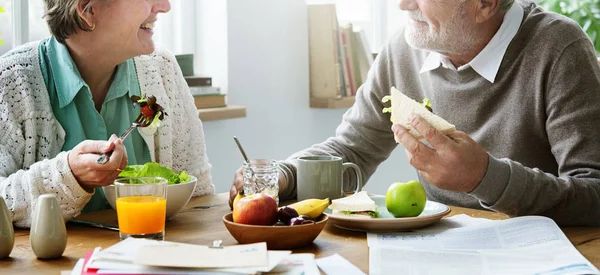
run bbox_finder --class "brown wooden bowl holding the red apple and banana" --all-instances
[223,213,329,250]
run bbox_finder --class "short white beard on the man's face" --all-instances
[404,5,481,54]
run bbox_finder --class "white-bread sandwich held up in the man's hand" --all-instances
[382,87,456,142]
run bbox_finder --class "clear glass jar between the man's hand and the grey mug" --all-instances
[244,159,279,205]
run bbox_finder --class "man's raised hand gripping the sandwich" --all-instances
[392,114,488,192]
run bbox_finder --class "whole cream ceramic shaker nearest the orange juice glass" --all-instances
[29,194,67,259]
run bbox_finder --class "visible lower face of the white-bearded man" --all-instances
[400,0,481,54]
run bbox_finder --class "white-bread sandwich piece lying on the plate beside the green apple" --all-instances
[329,191,379,218]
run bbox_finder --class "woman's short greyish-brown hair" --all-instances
[44,0,109,44]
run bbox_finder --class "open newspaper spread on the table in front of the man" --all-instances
[368,216,600,275]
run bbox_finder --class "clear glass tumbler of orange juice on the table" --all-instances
[115,177,167,240]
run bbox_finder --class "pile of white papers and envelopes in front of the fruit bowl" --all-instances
[71,238,318,275]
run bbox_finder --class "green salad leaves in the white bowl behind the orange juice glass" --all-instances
[119,162,191,184]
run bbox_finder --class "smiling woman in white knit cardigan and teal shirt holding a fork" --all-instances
[0,0,214,227]
